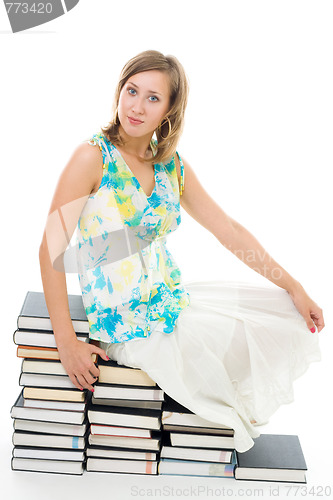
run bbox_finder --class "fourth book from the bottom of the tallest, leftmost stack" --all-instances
[13,418,88,436]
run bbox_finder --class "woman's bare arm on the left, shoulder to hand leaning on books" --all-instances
[39,143,108,390]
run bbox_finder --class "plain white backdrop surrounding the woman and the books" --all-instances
[0,0,333,500]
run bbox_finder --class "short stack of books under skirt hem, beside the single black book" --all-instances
[158,394,237,478]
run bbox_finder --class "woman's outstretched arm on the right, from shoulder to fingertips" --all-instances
[177,159,325,331]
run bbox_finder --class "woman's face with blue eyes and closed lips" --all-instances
[118,70,170,138]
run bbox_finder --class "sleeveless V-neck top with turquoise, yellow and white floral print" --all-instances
[77,133,190,342]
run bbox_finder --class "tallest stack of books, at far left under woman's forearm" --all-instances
[11,292,92,474]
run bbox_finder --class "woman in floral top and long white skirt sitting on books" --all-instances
[40,51,324,451]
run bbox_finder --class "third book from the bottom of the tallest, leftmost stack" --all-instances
[12,431,86,450]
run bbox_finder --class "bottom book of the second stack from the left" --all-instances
[87,457,157,474]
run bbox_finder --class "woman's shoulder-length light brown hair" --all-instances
[101,50,188,163]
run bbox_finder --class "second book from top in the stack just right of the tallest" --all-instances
[94,382,164,401]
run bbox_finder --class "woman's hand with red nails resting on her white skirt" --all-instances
[288,283,325,333]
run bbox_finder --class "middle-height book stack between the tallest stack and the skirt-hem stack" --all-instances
[87,359,164,475]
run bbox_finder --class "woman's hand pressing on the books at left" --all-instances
[58,339,109,392]
